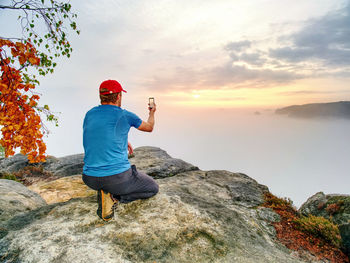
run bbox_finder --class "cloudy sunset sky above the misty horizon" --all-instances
[0,0,350,108]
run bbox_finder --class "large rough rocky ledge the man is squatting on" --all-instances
[0,147,344,263]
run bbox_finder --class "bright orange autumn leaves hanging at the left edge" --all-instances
[0,39,48,163]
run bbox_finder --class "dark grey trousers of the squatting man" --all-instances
[83,165,159,203]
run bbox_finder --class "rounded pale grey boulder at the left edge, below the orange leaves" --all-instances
[0,179,46,222]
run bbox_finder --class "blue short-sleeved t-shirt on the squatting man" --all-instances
[83,104,142,177]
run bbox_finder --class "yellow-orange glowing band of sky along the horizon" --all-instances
[153,79,350,108]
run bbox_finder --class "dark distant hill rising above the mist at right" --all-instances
[275,101,350,119]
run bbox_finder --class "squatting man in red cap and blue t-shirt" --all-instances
[83,80,159,221]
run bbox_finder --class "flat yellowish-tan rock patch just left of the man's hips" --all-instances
[28,175,96,204]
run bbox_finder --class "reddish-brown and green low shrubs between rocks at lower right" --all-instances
[262,193,349,263]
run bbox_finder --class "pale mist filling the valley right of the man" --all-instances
[129,106,350,207]
